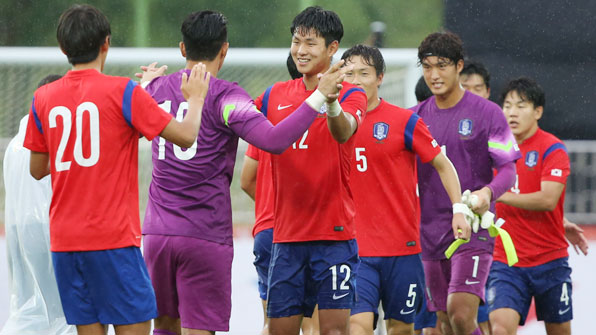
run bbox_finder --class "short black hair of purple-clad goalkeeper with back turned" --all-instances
[180,10,228,61]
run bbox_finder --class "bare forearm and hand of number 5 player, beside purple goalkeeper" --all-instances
[430,152,471,239]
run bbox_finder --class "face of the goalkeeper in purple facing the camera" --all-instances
[421,56,464,97]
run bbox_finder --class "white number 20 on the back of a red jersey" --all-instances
[49,102,99,171]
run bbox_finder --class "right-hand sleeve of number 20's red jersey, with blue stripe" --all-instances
[127,80,173,140]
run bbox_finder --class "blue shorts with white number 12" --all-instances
[267,240,360,318]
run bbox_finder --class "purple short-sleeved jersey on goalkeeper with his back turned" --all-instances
[143,70,263,245]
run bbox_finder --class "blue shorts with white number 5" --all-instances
[351,254,424,323]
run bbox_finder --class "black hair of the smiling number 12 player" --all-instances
[290,6,344,46]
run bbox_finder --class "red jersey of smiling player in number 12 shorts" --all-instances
[255,78,366,242]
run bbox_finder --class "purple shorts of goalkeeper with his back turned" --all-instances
[143,235,234,331]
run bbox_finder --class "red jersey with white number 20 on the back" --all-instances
[24,70,172,251]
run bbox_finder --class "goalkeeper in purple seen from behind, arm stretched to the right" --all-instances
[143,11,342,334]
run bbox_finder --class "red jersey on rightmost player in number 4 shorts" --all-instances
[494,129,569,267]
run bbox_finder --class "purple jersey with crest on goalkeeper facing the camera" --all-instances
[412,91,520,260]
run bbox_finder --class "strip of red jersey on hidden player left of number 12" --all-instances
[246,144,274,237]
